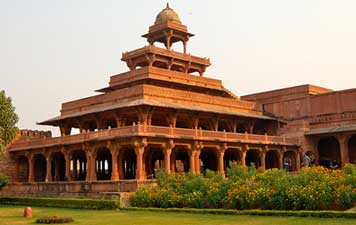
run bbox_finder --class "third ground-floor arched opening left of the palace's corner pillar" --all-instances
[70,150,87,181]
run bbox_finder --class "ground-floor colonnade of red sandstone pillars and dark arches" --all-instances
[15,138,300,182]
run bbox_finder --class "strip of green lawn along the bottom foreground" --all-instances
[0,205,356,225]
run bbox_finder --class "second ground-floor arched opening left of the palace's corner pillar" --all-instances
[95,148,112,180]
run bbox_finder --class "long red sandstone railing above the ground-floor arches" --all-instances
[8,124,299,151]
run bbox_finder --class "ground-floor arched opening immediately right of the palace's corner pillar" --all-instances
[143,146,165,179]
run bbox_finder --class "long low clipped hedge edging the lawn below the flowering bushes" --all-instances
[121,207,356,218]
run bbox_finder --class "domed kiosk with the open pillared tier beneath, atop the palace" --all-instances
[121,4,211,76]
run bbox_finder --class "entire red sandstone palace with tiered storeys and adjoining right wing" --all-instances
[0,5,356,197]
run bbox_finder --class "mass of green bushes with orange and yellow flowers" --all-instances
[131,164,356,210]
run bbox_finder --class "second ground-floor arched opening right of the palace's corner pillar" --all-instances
[171,147,190,173]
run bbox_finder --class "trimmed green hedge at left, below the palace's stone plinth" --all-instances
[0,197,120,209]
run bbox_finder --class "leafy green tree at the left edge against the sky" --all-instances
[0,91,19,152]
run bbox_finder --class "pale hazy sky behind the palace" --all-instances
[0,0,356,135]
